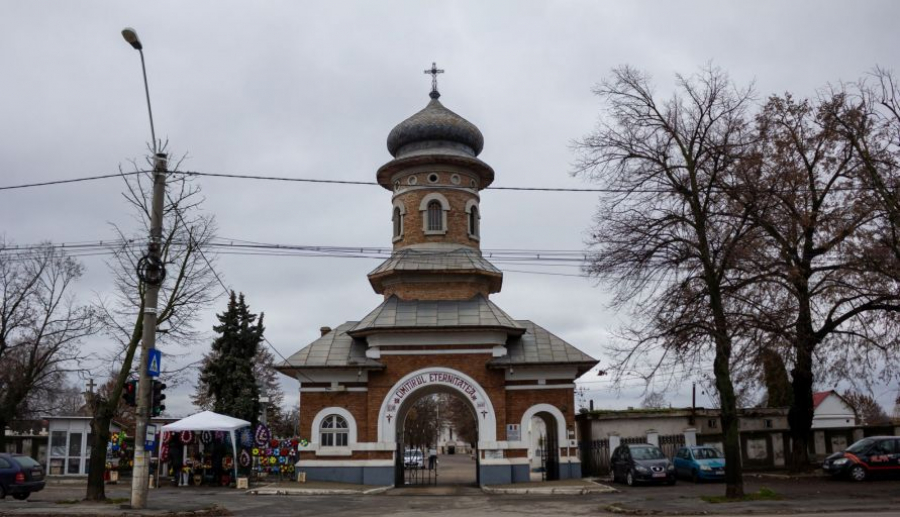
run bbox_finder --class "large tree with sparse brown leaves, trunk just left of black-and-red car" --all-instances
[725,90,900,470]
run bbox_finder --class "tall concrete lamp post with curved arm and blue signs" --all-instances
[122,27,167,508]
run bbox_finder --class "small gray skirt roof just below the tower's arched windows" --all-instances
[369,247,503,277]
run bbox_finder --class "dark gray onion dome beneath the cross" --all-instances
[387,92,484,158]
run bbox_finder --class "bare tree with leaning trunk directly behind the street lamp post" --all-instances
[85,157,221,500]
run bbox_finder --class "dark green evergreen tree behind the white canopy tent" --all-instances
[198,291,265,424]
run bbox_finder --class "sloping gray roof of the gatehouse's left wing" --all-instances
[277,321,383,369]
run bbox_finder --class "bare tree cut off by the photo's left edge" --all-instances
[0,241,95,450]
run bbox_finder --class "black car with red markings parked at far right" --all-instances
[822,436,900,481]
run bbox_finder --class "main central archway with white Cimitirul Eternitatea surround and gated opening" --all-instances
[378,367,496,487]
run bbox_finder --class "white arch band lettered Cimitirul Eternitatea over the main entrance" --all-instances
[378,366,497,443]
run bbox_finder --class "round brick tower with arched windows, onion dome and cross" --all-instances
[369,64,503,300]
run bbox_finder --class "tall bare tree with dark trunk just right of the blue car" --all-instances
[576,63,752,497]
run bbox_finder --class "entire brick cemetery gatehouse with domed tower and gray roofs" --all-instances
[277,71,597,485]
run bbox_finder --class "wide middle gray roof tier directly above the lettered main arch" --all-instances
[347,295,525,336]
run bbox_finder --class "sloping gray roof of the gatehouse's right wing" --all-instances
[491,320,597,366]
